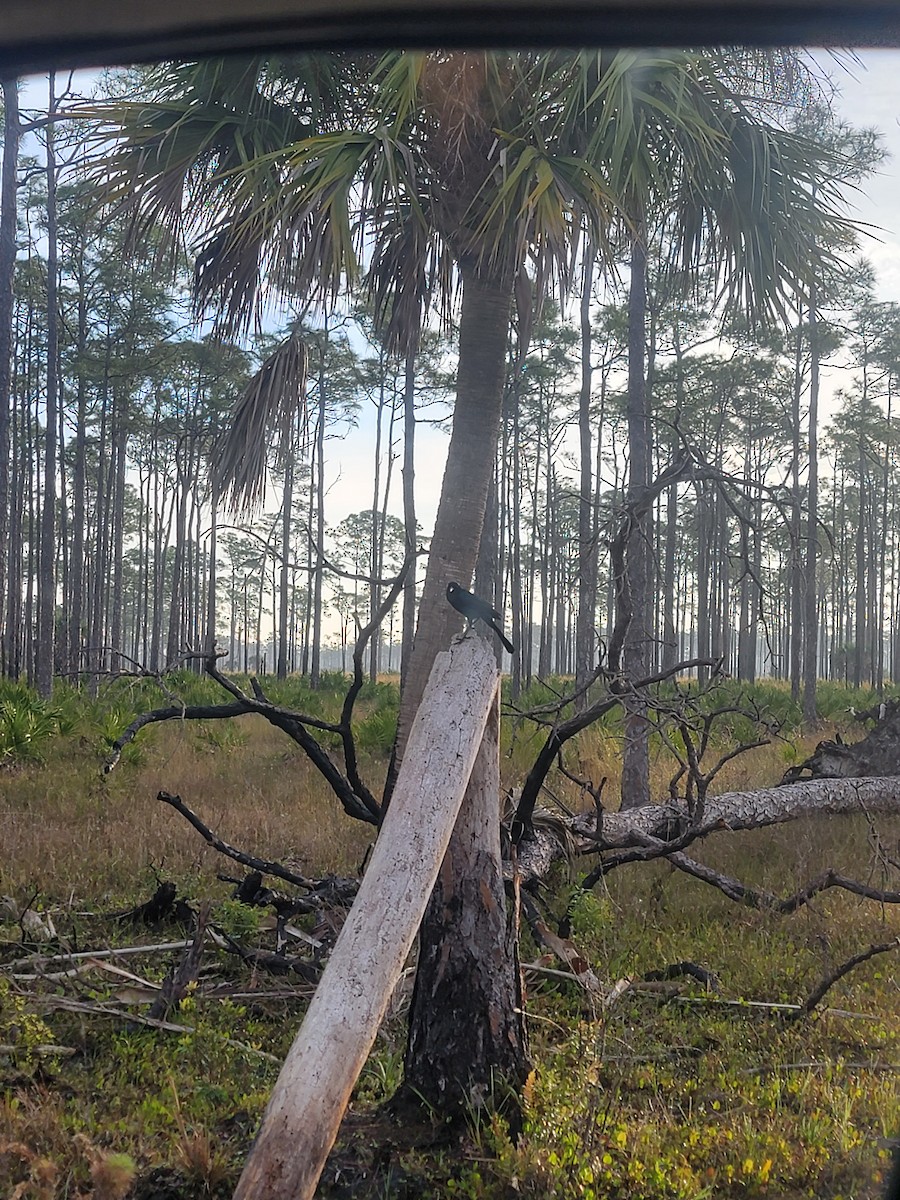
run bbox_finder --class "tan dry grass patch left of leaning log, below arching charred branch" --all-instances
[0,716,374,899]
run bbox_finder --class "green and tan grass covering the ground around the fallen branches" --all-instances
[0,679,900,1200]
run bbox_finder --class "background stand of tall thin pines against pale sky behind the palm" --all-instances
[0,54,900,720]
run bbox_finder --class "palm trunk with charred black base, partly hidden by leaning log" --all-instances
[388,268,527,1112]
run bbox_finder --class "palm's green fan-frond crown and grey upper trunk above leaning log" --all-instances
[95,52,859,752]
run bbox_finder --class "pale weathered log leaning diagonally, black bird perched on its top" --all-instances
[235,637,498,1200]
